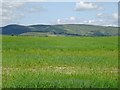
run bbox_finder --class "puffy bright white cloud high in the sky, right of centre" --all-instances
[75,1,103,11]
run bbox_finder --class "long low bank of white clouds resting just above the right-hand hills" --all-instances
[52,13,118,26]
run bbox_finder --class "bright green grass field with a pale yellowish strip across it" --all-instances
[2,36,118,88]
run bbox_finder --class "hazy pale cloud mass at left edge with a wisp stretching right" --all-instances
[0,0,45,26]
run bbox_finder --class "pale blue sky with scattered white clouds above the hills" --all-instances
[0,1,118,26]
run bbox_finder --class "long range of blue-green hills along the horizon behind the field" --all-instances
[2,24,118,36]
